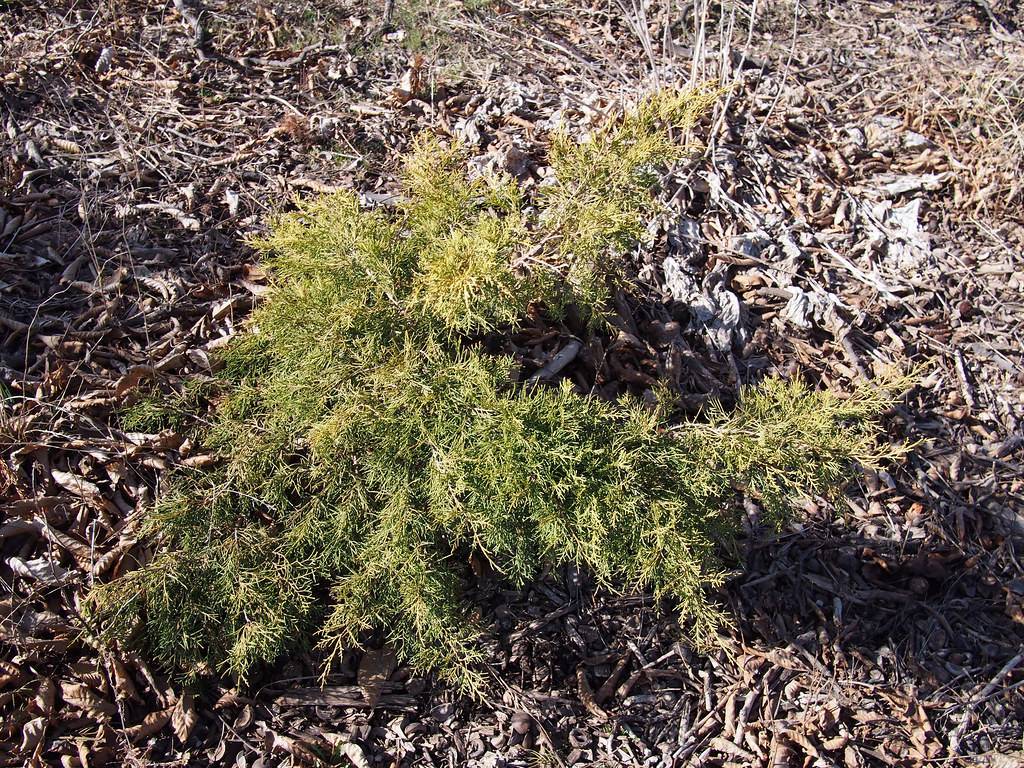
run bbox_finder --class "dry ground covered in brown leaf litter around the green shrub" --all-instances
[0,0,1024,767]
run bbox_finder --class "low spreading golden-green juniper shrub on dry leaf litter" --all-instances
[93,92,905,688]
